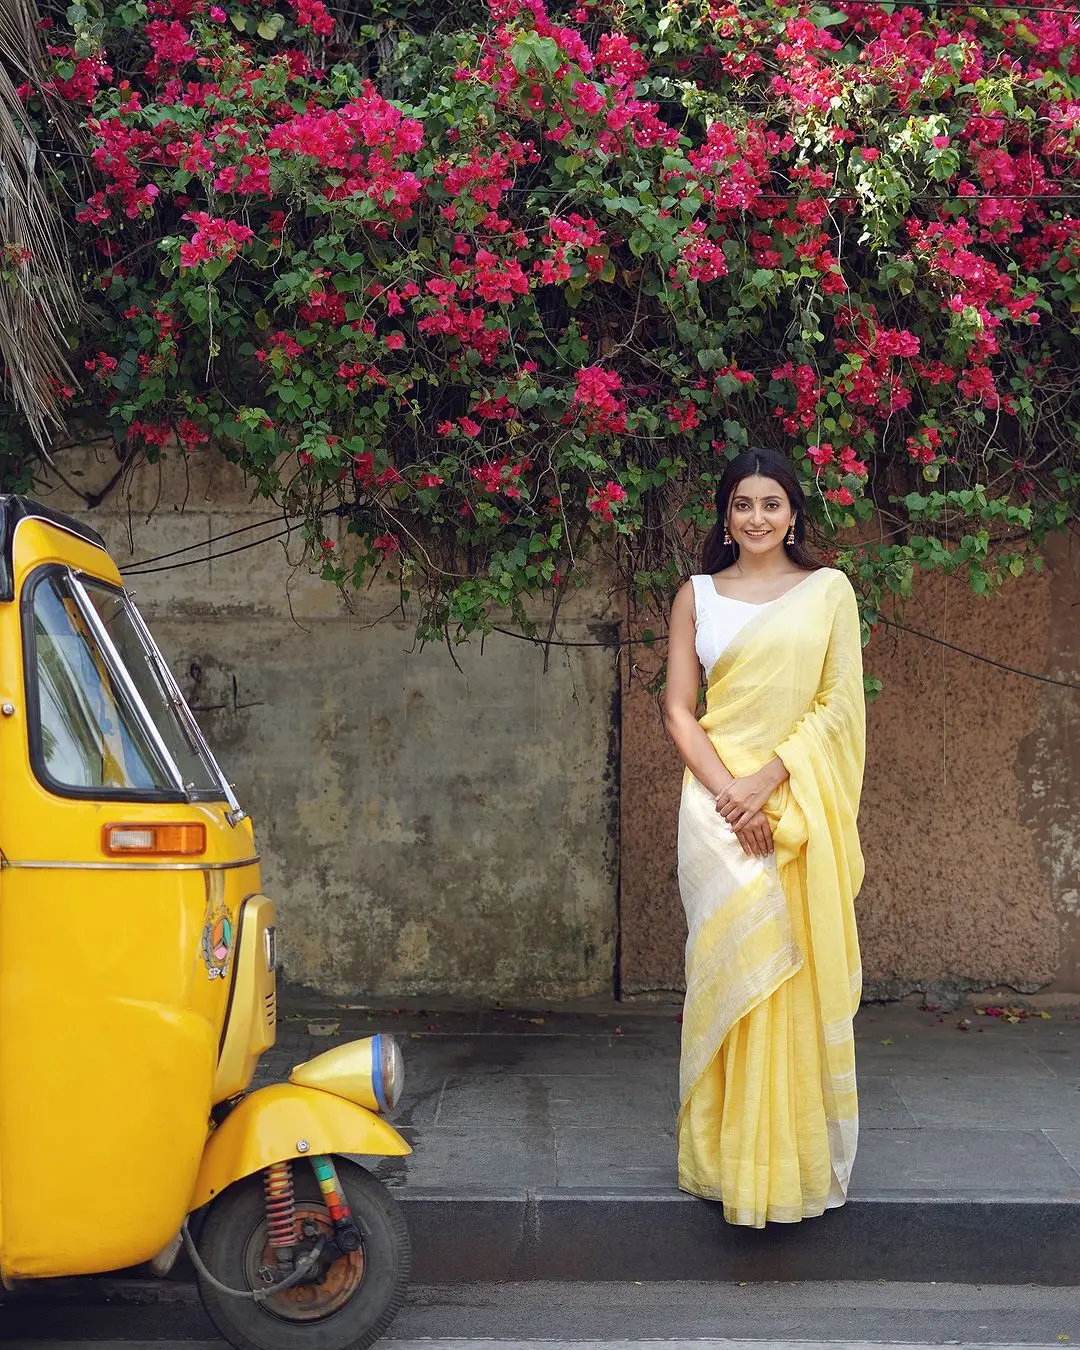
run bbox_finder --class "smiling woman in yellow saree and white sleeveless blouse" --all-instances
[664,450,865,1229]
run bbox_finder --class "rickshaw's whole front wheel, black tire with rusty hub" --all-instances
[198,1158,410,1350]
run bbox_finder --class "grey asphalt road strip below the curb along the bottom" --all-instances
[0,1283,1080,1350]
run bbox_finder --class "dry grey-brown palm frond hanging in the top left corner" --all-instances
[0,0,81,450]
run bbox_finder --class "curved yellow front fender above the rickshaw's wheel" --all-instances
[189,1083,412,1211]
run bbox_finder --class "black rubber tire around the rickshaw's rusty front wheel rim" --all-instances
[198,1157,412,1350]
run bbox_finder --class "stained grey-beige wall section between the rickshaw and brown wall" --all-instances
[40,456,618,999]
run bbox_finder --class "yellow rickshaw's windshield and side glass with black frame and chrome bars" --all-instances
[31,570,230,801]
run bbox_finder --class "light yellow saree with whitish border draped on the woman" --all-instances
[678,568,865,1227]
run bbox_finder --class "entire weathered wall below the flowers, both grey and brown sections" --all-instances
[29,455,1080,1000]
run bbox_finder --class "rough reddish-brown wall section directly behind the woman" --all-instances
[621,540,1080,998]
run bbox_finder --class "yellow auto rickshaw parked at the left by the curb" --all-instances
[0,495,409,1350]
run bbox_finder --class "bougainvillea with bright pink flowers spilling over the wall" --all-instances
[4,0,1080,635]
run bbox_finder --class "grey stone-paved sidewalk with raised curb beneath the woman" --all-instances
[261,995,1080,1284]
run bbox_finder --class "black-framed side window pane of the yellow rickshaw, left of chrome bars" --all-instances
[34,575,173,791]
